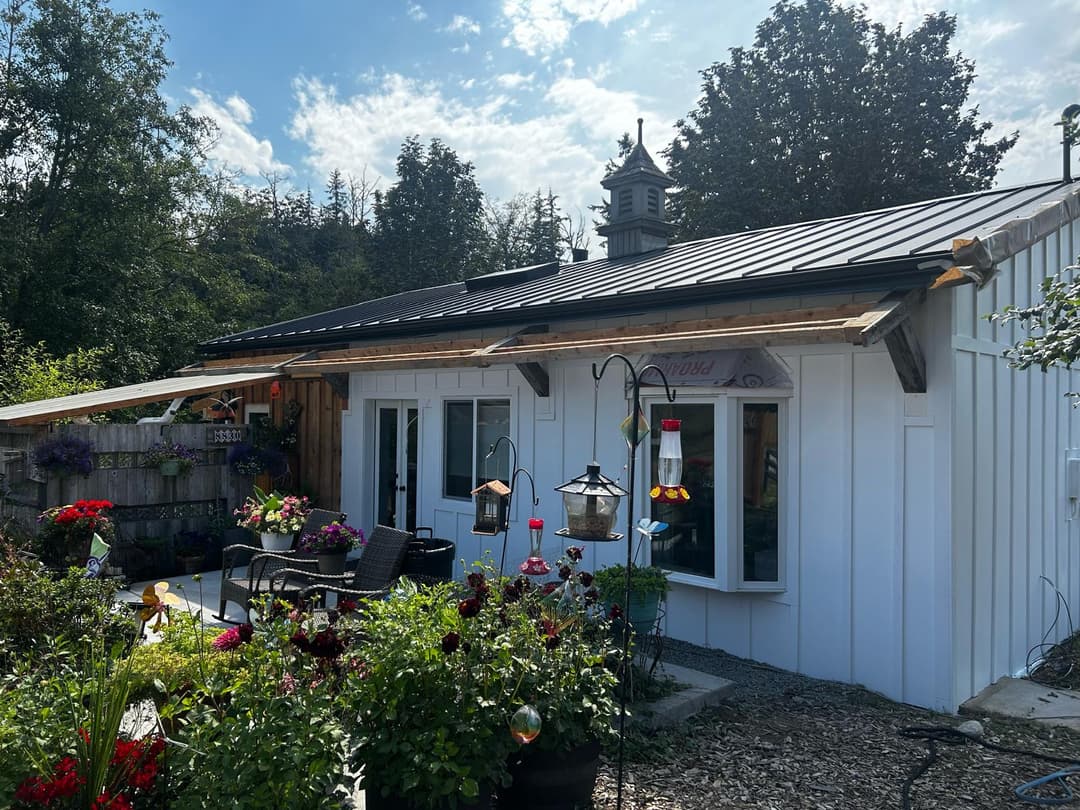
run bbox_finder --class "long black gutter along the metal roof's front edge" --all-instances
[199,253,951,354]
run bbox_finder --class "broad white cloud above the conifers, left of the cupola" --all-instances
[291,73,656,211]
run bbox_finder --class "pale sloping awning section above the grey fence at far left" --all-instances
[0,370,282,424]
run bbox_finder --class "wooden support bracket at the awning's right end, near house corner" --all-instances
[843,288,927,394]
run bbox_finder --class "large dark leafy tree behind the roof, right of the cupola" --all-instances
[666,0,1016,239]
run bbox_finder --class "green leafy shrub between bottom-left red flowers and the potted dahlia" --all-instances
[162,600,355,810]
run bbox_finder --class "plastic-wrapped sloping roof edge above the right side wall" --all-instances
[950,186,1080,289]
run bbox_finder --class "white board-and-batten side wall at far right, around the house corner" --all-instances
[951,221,1080,703]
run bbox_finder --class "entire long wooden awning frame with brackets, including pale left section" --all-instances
[0,289,926,426]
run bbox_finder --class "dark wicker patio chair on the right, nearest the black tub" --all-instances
[271,526,416,600]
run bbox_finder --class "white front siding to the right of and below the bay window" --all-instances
[666,296,951,707]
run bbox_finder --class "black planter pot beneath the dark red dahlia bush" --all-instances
[498,741,600,810]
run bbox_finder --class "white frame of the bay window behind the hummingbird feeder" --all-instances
[636,387,794,593]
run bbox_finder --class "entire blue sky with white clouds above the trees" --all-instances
[120,0,1080,220]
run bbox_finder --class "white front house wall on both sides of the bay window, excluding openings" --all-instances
[342,295,950,706]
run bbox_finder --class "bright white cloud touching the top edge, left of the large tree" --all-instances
[502,0,638,56]
